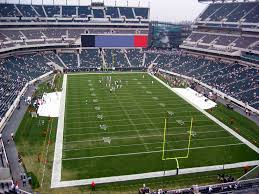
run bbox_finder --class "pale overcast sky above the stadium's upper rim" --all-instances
[0,0,206,22]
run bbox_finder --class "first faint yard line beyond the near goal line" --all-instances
[63,136,234,152]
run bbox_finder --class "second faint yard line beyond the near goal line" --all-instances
[64,130,228,144]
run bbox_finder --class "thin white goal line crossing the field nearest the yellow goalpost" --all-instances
[62,143,244,161]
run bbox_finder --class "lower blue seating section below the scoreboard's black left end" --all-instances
[80,49,103,68]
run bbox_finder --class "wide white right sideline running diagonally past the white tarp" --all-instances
[150,74,259,154]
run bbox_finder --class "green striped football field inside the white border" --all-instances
[62,73,259,180]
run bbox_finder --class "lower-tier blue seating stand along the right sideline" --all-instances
[155,52,259,108]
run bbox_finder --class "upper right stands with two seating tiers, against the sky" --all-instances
[183,1,259,56]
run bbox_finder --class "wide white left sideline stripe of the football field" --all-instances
[51,74,67,188]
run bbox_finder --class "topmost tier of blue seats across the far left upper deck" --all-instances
[0,4,149,22]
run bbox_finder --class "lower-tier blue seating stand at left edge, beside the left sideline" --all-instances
[0,54,52,120]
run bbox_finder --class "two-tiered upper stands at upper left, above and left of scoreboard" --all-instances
[0,3,149,51]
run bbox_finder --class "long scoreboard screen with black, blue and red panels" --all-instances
[81,34,148,48]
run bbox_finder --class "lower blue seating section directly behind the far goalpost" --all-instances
[104,49,129,68]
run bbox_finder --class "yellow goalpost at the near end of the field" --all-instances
[162,116,193,175]
